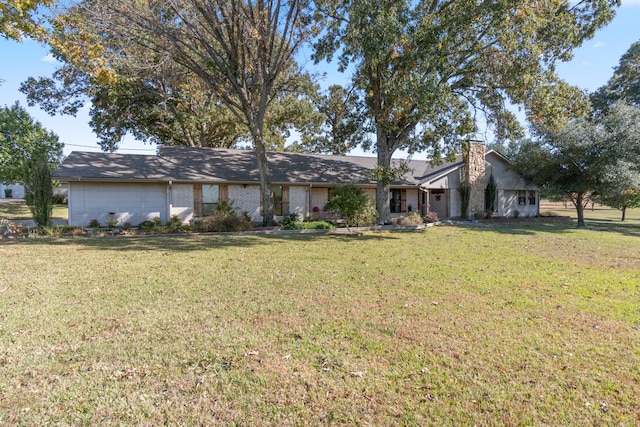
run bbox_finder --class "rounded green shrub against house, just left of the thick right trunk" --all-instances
[324,184,377,227]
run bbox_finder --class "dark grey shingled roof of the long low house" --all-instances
[53,146,461,186]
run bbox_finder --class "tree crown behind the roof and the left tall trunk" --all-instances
[20,50,315,151]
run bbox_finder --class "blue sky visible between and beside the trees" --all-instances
[0,0,640,159]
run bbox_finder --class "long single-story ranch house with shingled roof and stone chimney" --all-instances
[53,143,539,226]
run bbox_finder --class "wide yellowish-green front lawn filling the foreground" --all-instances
[0,221,640,426]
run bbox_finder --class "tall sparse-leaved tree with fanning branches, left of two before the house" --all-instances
[67,0,310,225]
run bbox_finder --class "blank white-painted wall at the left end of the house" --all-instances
[69,182,168,227]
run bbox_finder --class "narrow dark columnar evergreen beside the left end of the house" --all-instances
[24,152,53,227]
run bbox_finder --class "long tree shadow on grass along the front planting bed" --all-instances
[18,231,402,252]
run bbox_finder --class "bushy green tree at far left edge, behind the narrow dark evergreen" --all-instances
[0,103,63,184]
